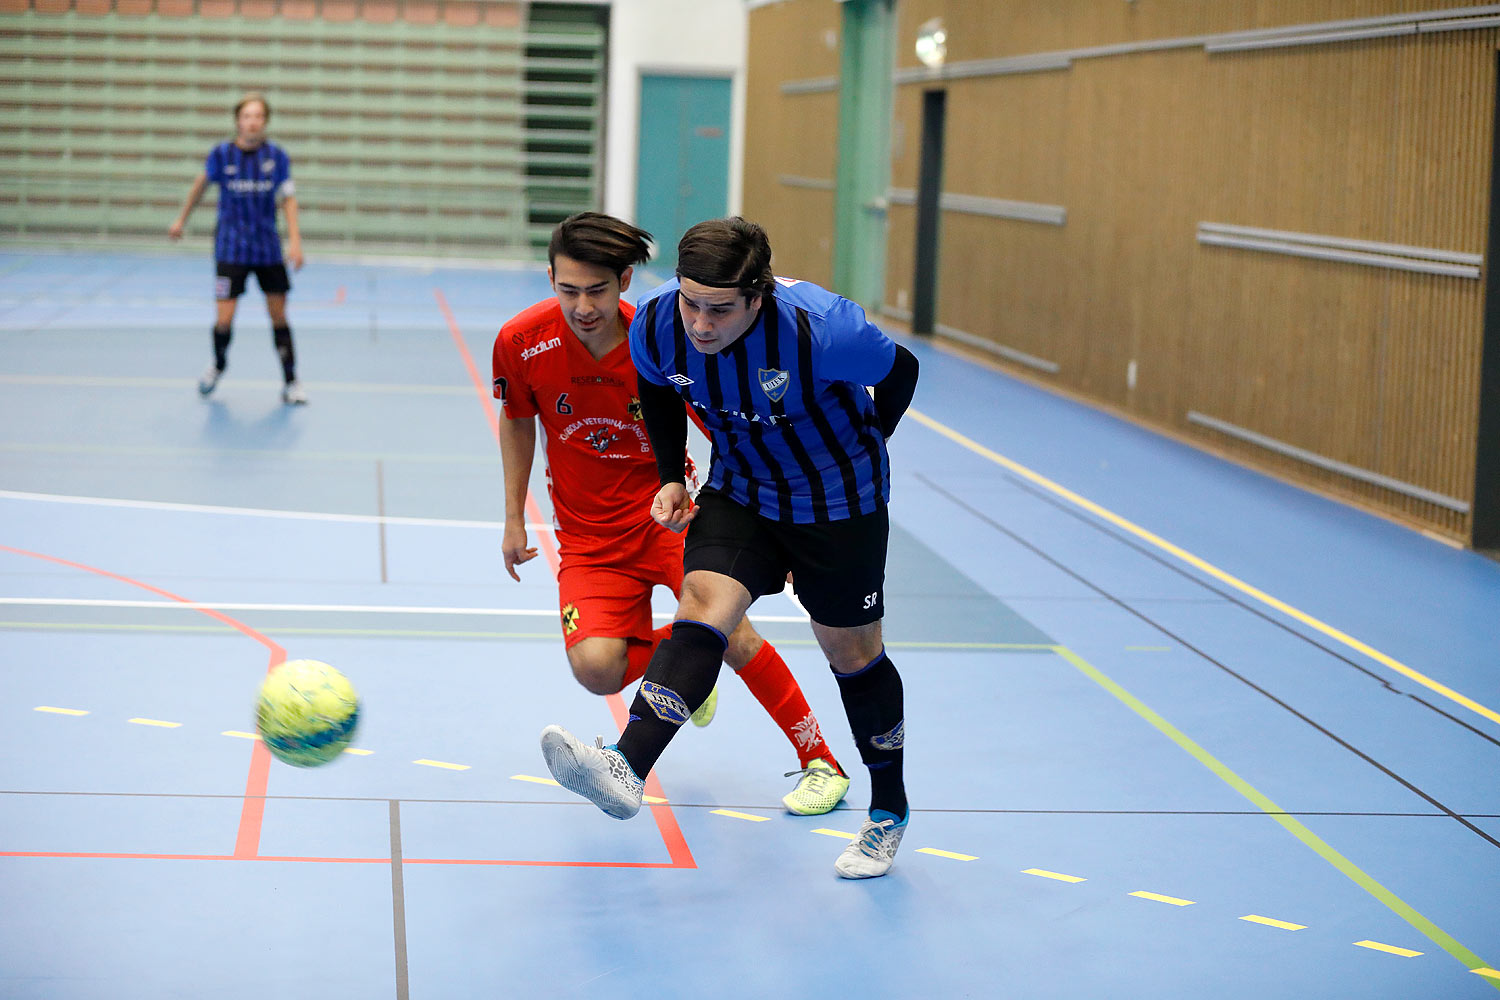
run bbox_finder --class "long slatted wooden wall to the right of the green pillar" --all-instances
[887,0,1500,540]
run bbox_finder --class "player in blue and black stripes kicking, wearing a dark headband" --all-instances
[542,217,917,879]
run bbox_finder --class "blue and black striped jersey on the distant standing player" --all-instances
[203,142,294,267]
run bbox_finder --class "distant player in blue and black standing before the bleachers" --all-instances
[168,93,308,403]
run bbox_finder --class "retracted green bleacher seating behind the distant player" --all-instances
[0,10,605,253]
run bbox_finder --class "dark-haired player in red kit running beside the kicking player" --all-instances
[492,211,849,816]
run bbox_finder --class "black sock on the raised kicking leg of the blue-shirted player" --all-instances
[618,622,729,778]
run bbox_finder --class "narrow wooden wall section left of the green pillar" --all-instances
[743,0,840,285]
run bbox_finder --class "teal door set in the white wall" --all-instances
[636,76,729,274]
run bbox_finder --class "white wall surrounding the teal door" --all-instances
[605,0,749,229]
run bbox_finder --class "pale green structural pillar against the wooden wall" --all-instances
[834,0,896,310]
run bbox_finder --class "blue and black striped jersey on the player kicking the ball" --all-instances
[630,277,896,523]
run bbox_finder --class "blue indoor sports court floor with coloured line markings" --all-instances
[0,250,1500,1000]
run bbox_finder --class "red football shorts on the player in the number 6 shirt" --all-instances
[558,520,683,649]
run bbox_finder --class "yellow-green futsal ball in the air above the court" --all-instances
[255,660,360,768]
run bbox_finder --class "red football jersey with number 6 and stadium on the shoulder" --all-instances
[492,298,662,535]
